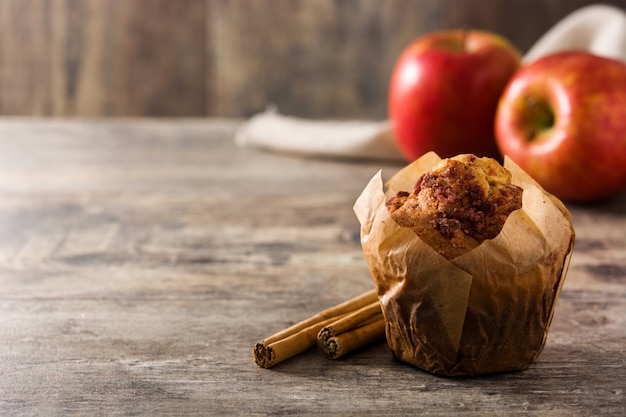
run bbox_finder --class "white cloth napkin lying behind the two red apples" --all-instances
[235,4,626,161]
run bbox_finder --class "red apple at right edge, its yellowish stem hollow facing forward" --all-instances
[496,52,626,202]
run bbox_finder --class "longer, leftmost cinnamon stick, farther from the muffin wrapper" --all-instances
[252,290,378,368]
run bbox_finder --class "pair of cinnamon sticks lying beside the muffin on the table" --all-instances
[253,290,385,368]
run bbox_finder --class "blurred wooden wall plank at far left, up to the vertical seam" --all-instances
[0,0,206,116]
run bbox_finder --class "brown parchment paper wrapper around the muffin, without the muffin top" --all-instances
[354,152,574,376]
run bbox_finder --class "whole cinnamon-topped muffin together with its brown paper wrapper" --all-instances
[354,153,574,376]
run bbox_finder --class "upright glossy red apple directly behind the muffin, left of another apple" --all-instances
[389,30,521,161]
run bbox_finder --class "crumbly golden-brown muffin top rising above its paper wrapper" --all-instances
[386,154,522,259]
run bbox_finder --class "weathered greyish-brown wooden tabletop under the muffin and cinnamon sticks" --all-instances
[0,119,626,416]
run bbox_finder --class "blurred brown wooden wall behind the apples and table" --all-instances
[0,0,626,119]
